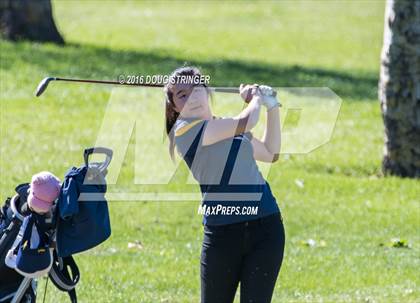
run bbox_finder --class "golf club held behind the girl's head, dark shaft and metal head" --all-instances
[35,77,277,97]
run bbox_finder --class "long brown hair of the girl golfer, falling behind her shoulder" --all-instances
[164,66,211,160]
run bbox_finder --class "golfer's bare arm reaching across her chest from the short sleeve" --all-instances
[202,96,261,145]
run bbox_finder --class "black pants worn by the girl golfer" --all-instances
[201,214,285,303]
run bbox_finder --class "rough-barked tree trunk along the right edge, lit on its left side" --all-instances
[379,0,420,178]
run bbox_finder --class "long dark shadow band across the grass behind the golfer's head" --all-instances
[1,42,378,100]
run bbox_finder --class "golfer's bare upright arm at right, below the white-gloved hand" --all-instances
[251,106,281,162]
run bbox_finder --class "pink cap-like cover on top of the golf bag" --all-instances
[28,171,60,214]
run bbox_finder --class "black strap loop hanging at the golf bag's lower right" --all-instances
[49,251,80,303]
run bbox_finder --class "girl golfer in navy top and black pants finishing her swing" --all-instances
[165,67,285,303]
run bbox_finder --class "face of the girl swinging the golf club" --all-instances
[173,84,208,118]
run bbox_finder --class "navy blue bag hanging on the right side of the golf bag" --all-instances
[57,165,111,257]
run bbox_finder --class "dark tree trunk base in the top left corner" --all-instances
[0,0,64,44]
